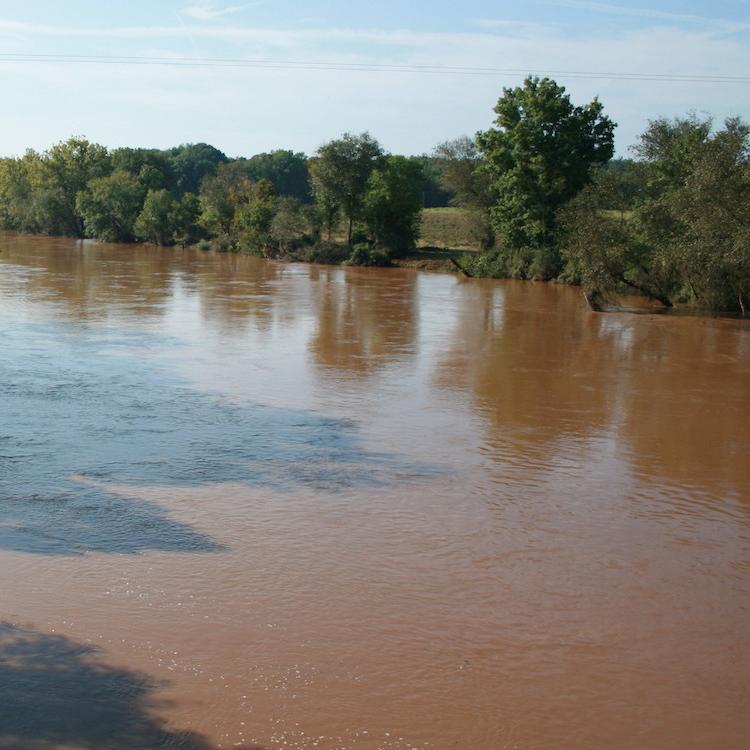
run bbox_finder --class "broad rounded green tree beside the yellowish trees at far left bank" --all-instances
[76,172,144,242]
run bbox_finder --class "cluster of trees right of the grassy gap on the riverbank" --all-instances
[454,78,750,313]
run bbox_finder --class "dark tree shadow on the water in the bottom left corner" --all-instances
[0,624,228,750]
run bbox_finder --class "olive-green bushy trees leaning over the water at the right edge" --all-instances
[563,116,750,311]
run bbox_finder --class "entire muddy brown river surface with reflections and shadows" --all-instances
[0,235,750,750]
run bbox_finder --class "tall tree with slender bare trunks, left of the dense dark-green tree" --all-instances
[310,133,383,246]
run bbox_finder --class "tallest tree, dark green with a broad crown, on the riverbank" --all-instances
[477,77,615,278]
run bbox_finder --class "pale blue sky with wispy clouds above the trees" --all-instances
[0,0,750,155]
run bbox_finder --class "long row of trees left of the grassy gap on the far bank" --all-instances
[0,133,450,264]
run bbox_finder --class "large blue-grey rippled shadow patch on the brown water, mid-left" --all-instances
[0,321,435,555]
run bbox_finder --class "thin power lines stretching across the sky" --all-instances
[0,52,750,84]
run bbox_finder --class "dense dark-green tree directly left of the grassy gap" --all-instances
[364,156,423,255]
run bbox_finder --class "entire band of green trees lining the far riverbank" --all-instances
[0,77,750,312]
